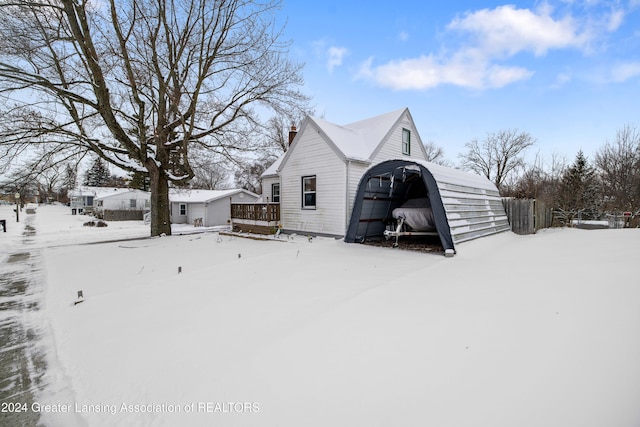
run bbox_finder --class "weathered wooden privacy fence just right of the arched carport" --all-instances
[502,197,553,234]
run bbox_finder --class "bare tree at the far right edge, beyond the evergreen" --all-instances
[595,125,640,211]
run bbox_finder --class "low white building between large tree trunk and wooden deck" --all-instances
[169,189,259,227]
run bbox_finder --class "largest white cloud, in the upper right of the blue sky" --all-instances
[357,0,604,90]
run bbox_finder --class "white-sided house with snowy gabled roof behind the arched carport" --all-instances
[261,108,427,236]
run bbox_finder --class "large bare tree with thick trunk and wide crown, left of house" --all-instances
[0,0,308,236]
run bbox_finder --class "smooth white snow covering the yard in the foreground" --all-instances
[0,206,640,427]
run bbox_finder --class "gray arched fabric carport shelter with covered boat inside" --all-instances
[344,159,510,255]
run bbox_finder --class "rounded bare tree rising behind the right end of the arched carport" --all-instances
[460,129,536,189]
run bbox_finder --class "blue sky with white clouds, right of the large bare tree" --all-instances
[278,0,640,163]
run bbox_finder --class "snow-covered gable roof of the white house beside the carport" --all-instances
[261,107,424,178]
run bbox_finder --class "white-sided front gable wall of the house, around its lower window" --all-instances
[280,127,346,236]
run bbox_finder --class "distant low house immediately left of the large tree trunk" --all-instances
[93,188,151,221]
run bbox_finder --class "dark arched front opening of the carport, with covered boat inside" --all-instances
[356,164,444,252]
